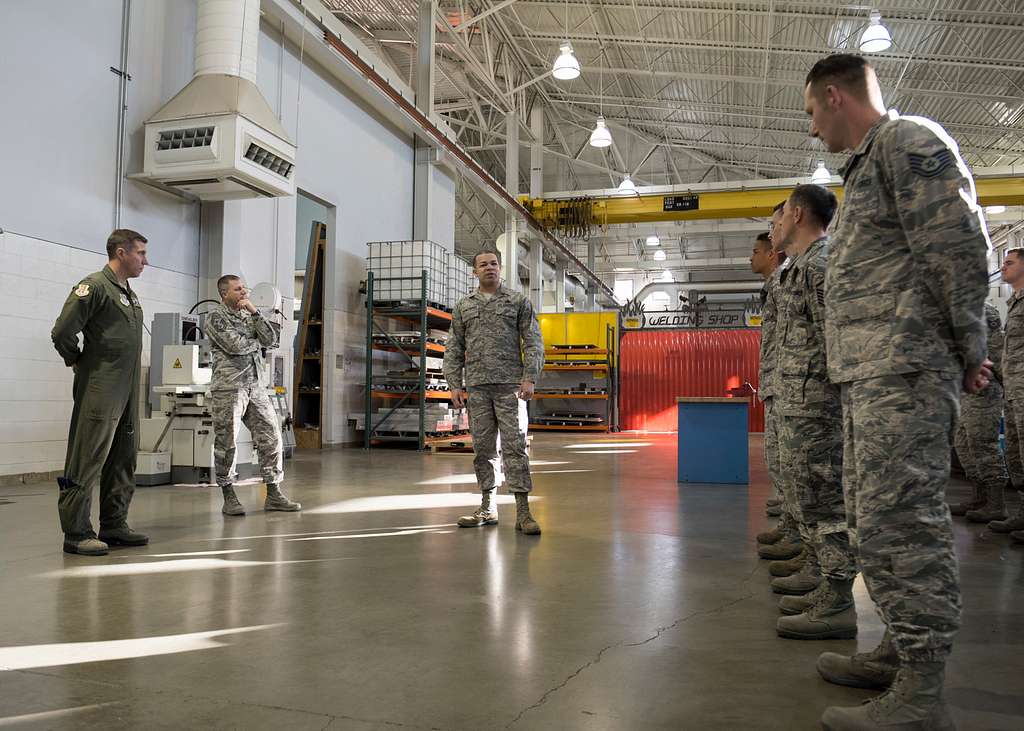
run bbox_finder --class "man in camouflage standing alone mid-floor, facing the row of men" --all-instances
[444,251,544,535]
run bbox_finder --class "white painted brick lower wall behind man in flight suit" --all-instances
[0,232,197,475]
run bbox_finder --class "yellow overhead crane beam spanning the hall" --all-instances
[520,177,1024,228]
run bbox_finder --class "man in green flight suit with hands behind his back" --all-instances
[50,228,150,556]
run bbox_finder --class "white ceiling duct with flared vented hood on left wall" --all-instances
[132,0,296,201]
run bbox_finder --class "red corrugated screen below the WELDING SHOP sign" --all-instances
[618,329,765,432]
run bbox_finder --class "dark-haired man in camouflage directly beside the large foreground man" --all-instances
[772,185,857,640]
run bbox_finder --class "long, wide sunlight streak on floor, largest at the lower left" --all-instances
[0,622,282,671]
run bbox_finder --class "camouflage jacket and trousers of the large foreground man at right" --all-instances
[825,112,989,662]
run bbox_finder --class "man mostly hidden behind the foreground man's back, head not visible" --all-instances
[949,302,1007,523]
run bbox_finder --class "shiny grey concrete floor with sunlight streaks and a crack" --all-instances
[0,434,1024,731]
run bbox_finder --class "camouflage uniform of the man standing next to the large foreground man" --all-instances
[775,238,857,582]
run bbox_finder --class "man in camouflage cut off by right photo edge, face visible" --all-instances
[988,249,1024,543]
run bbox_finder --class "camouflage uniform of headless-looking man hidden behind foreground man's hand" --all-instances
[954,302,1007,495]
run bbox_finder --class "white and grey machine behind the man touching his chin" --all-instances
[135,285,295,485]
